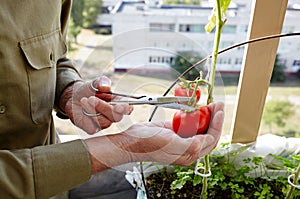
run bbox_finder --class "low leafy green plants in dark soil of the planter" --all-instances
[147,143,300,199]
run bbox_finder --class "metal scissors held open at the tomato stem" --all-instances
[82,91,196,117]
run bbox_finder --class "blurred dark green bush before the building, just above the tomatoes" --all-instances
[171,51,203,80]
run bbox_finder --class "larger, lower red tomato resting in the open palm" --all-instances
[172,106,211,137]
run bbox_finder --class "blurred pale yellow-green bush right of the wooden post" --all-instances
[263,100,295,132]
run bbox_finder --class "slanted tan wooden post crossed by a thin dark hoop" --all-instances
[231,0,288,143]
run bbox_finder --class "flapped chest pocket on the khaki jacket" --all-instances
[20,30,67,124]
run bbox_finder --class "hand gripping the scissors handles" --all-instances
[60,76,133,134]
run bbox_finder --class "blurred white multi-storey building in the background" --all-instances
[108,0,300,73]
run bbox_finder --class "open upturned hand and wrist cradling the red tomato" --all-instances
[85,103,224,172]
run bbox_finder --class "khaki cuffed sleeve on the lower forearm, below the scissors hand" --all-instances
[0,140,92,199]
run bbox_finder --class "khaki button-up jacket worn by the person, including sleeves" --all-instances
[0,0,91,199]
